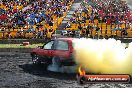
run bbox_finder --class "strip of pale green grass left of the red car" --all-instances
[0,43,43,48]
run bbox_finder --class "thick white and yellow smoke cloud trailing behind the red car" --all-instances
[74,38,132,75]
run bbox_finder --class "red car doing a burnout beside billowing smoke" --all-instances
[31,38,75,66]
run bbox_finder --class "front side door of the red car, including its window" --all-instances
[39,40,54,57]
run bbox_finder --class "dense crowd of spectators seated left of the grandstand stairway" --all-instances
[0,0,74,38]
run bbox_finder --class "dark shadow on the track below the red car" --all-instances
[19,64,76,80]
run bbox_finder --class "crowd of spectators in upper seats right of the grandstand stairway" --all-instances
[70,0,132,24]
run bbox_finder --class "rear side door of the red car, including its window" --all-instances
[53,40,69,59]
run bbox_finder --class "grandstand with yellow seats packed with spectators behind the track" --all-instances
[0,0,132,39]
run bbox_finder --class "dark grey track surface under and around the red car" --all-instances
[0,52,132,88]
